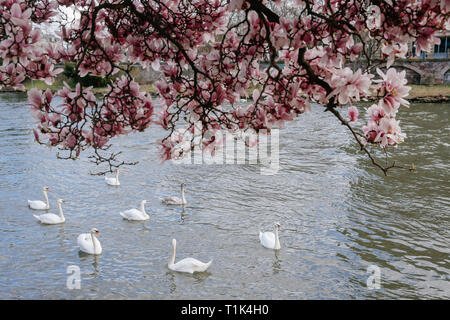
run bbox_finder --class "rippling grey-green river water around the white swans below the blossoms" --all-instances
[0,93,450,299]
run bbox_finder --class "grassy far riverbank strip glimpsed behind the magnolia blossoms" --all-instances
[0,80,450,103]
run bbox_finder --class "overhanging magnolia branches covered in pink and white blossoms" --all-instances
[0,0,450,174]
